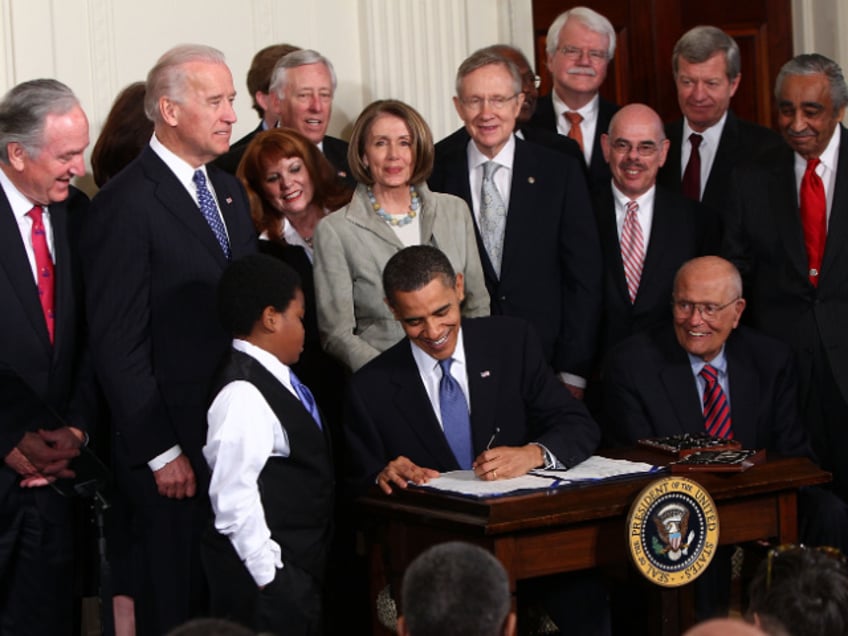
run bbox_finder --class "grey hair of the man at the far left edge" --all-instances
[0,79,79,164]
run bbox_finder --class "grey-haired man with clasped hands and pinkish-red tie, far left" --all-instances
[0,79,95,636]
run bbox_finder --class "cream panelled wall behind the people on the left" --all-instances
[0,0,532,191]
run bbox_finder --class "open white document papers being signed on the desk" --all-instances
[419,455,662,497]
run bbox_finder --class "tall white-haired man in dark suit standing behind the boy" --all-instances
[83,45,256,634]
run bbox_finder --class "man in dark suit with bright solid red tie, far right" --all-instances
[724,54,848,506]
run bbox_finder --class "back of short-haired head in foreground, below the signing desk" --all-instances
[398,541,515,636]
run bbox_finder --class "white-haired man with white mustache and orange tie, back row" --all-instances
[530,7,618,189]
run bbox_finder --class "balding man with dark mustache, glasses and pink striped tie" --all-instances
[594,104,719,358]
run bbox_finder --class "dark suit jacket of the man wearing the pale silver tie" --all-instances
[429,139,602,377]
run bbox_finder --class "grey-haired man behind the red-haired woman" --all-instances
[270,49,355,186]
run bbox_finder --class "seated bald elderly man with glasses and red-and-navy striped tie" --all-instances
[603,256,848,618]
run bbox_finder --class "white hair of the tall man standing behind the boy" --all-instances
[144,44,226,123]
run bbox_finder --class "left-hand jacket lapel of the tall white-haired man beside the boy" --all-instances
[141,146,227,267]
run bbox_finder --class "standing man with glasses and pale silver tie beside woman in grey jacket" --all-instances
[429,49,602,397]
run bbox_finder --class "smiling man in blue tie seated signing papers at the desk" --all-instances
[345,245,609,635]
